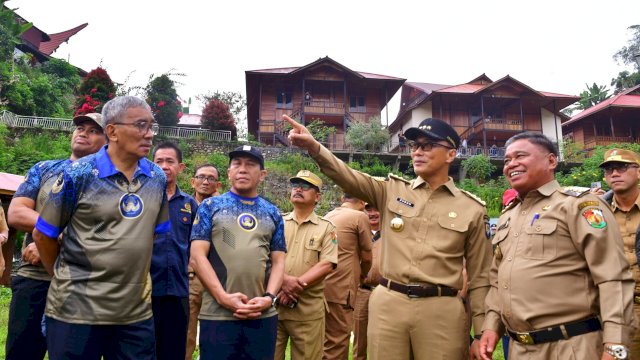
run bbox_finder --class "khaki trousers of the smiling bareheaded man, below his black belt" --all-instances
[509,331,604,360]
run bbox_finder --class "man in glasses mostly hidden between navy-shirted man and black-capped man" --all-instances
[185,164,222,360]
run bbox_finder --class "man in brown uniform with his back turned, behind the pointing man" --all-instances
[322,193,371,360]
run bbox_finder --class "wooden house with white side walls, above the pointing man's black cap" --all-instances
[389,74,579,158]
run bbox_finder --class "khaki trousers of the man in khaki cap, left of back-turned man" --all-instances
[274,317,324,360]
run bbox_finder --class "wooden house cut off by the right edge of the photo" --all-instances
[562,85,640,150]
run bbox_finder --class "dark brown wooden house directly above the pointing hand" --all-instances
[245,57,405,150]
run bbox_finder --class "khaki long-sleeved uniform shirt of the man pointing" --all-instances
[315,147,491,329]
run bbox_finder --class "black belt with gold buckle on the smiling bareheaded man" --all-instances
[507,317,602,345]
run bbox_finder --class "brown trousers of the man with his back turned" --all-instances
[322,302,353,360]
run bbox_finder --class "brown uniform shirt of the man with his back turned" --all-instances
[324,206,372,309]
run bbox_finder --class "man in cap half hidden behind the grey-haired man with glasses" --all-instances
[6,113,106,360]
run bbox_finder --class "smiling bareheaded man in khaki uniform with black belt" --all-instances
[480,132,634,360]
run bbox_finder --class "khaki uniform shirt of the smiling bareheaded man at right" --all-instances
[483,180,634,344]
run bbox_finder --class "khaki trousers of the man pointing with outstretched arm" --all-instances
[367,286,469,360]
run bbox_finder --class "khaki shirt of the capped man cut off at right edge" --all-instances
[611,196,640,294]
